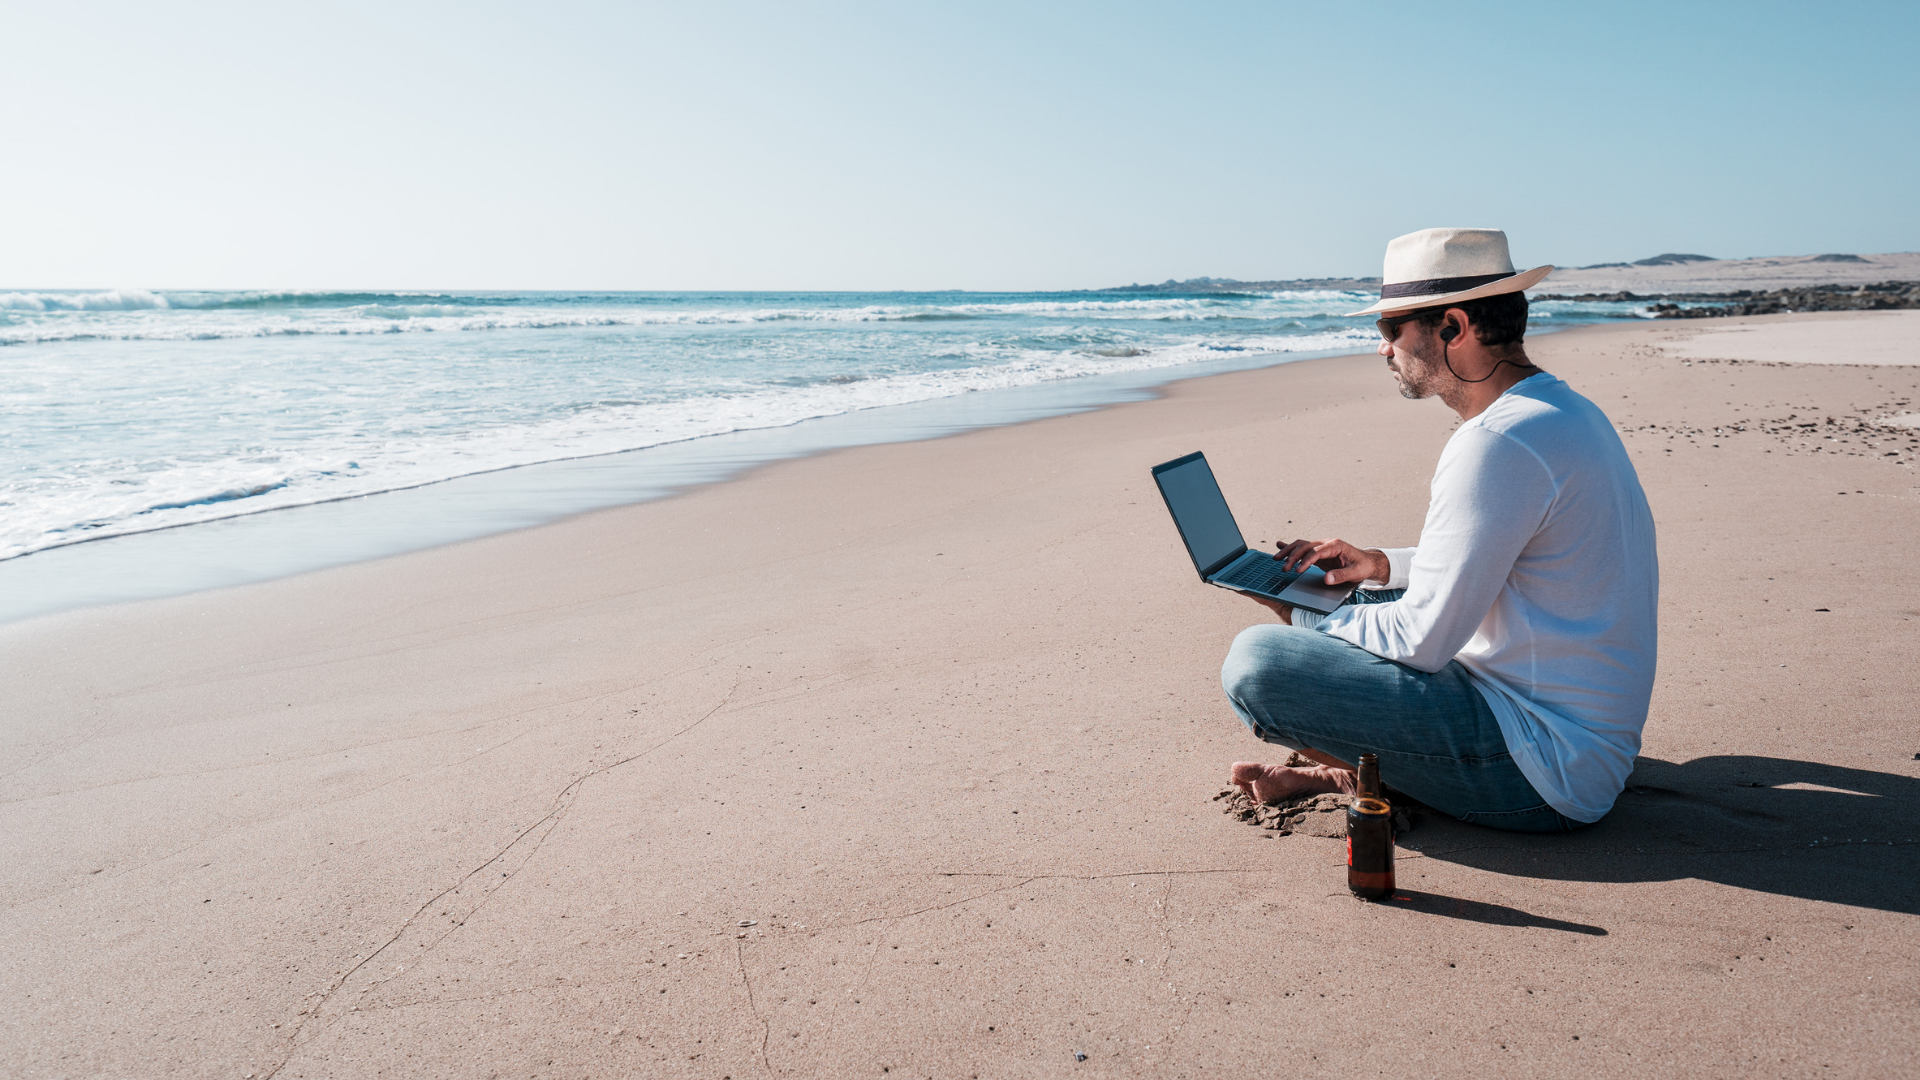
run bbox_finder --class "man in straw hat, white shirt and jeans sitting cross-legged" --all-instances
[1221,229,1659,832]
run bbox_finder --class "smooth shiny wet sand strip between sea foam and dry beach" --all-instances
[0,329,1382,625]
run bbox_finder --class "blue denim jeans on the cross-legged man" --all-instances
[1219,590,1584,832]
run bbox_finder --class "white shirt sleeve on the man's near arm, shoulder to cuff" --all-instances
[1319,427,1555,671]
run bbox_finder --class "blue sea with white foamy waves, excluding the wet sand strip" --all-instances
[0,284,1413,592]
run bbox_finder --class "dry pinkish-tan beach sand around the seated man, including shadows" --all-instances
[0,307,1920,1080]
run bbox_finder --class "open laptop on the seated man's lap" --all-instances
[1154,454,1359,615]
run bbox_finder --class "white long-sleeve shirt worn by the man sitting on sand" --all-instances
[1319,373,1659,821]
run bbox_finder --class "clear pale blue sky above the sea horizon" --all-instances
[0,0,1920,290]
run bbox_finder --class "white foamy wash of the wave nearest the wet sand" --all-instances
[0,329,1371,559]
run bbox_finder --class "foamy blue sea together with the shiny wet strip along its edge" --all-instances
[0,290,1644,621]
